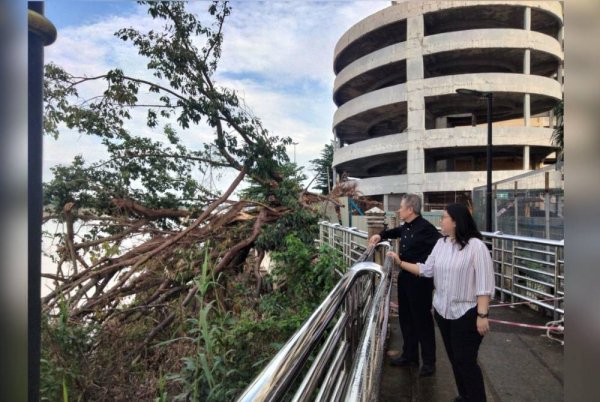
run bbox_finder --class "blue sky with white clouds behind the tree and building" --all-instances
[44,0,390,190]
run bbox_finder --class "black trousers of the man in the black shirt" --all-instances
[398,271,435,365]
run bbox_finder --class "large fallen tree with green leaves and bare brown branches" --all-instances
[44,2,298,319]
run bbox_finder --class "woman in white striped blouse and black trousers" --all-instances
[388,204,494,402]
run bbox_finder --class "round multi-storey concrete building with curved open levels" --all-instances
[333,1,564,210]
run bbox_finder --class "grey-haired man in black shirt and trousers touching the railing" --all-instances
[369,194,441,377]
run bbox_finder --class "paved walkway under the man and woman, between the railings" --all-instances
[380,284,564,402]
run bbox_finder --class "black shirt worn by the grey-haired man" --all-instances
[379,215,442,264]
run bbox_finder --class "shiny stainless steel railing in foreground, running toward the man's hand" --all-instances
[238,240,393,402]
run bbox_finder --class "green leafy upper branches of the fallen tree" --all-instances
[44,2,291,217]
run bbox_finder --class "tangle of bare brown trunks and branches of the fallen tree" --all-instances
[43,170,288,344]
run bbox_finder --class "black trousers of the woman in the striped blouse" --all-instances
[435,307,486,402]
